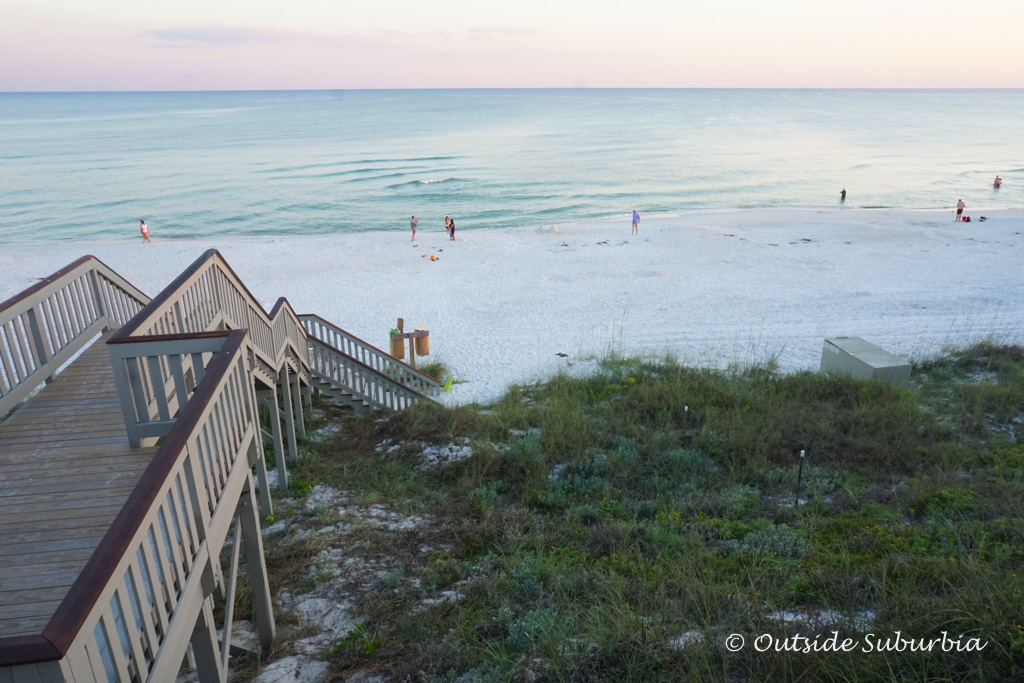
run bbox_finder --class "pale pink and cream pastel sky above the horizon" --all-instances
[0,0,1024,91]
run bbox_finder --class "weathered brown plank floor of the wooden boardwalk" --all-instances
[0,334,157,637]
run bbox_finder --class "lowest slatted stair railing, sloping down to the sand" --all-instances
[309,337,427,411]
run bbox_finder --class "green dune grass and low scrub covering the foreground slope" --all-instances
[274,343,1024,681]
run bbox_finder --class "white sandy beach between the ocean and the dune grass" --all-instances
[0,209,1024,402]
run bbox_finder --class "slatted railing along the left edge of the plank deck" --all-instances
[0,256,150,418]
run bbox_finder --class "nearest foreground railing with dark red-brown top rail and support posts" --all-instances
[0,331,273,681]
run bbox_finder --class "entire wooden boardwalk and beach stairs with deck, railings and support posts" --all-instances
[0,250,440,683]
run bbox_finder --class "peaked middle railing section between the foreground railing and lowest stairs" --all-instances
[108,249,309,445]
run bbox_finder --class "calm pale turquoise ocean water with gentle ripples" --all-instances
[0,90,1024,242]
